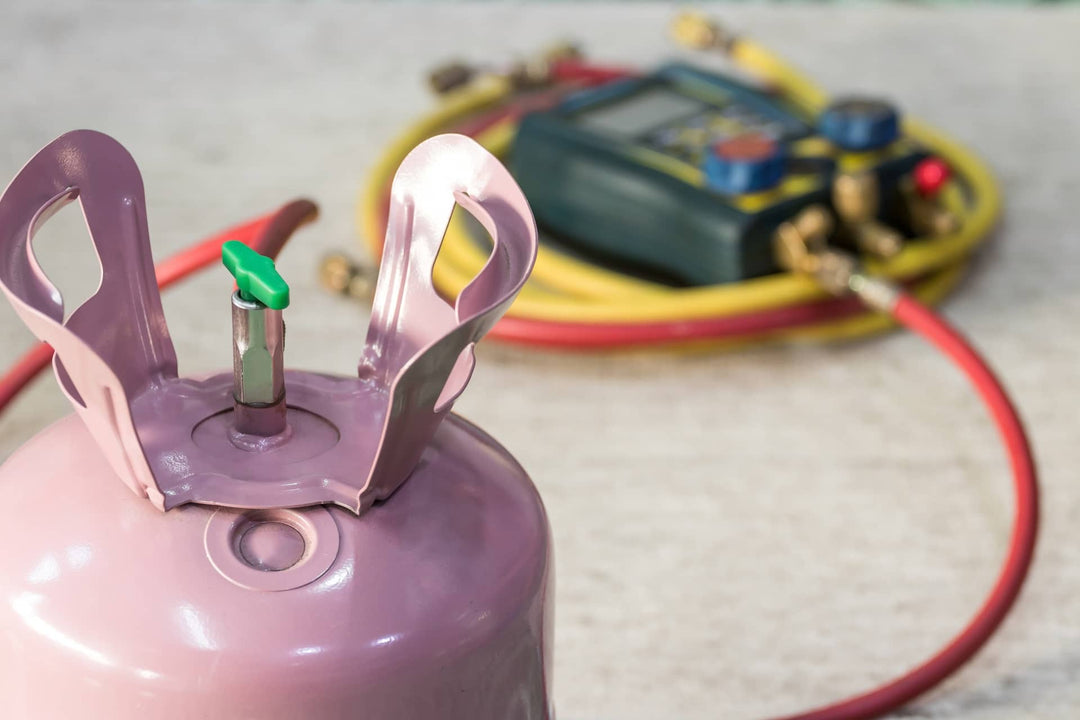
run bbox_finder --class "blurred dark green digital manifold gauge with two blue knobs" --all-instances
[511,65,928,285]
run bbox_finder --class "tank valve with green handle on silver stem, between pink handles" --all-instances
[221,241,288,437]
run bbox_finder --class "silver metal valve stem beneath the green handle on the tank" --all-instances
[232,290,286,436]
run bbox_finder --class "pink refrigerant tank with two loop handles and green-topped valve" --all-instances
[0,131,553,720]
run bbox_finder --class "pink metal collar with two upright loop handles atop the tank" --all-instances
[0,131,537,513]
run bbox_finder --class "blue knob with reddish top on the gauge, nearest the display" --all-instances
[704,133,784,195]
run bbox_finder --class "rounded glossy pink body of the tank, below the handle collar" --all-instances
[0,416,553,720]
